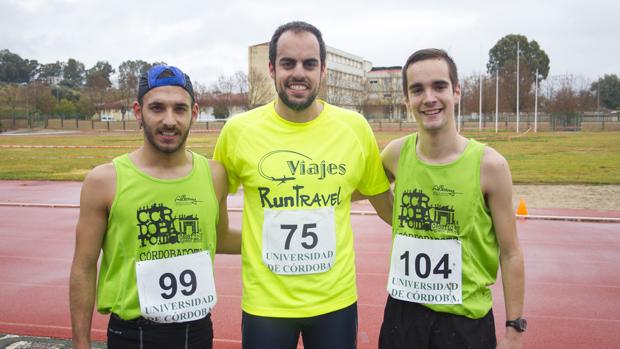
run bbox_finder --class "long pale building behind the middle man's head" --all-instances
[248,42,372,112]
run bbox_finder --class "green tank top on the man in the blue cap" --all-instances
[97,153,219,320]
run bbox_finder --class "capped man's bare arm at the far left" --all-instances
[69,164,116,349]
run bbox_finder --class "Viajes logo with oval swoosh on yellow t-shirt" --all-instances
[258,150,347,184]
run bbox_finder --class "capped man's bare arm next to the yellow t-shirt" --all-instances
[209,160,241,254]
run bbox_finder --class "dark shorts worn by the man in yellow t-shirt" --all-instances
[241,303,357,349]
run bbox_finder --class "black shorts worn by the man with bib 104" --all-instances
[379,296,497,349]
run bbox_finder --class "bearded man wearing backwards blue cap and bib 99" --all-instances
[70,65,240,348]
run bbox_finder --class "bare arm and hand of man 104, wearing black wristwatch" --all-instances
[481,147,525,348]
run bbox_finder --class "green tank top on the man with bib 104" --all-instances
[392,134,499,319]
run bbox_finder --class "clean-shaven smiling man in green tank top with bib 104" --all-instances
[379,49,526,349]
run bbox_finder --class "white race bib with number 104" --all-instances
[387,235,463,304]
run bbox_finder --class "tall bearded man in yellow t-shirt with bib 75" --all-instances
[214,22,391,349]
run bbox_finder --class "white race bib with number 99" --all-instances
[136,251,217,323]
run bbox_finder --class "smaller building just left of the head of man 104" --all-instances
[364,66,407,120]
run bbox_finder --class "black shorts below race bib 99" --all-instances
[108,314,213,349]
